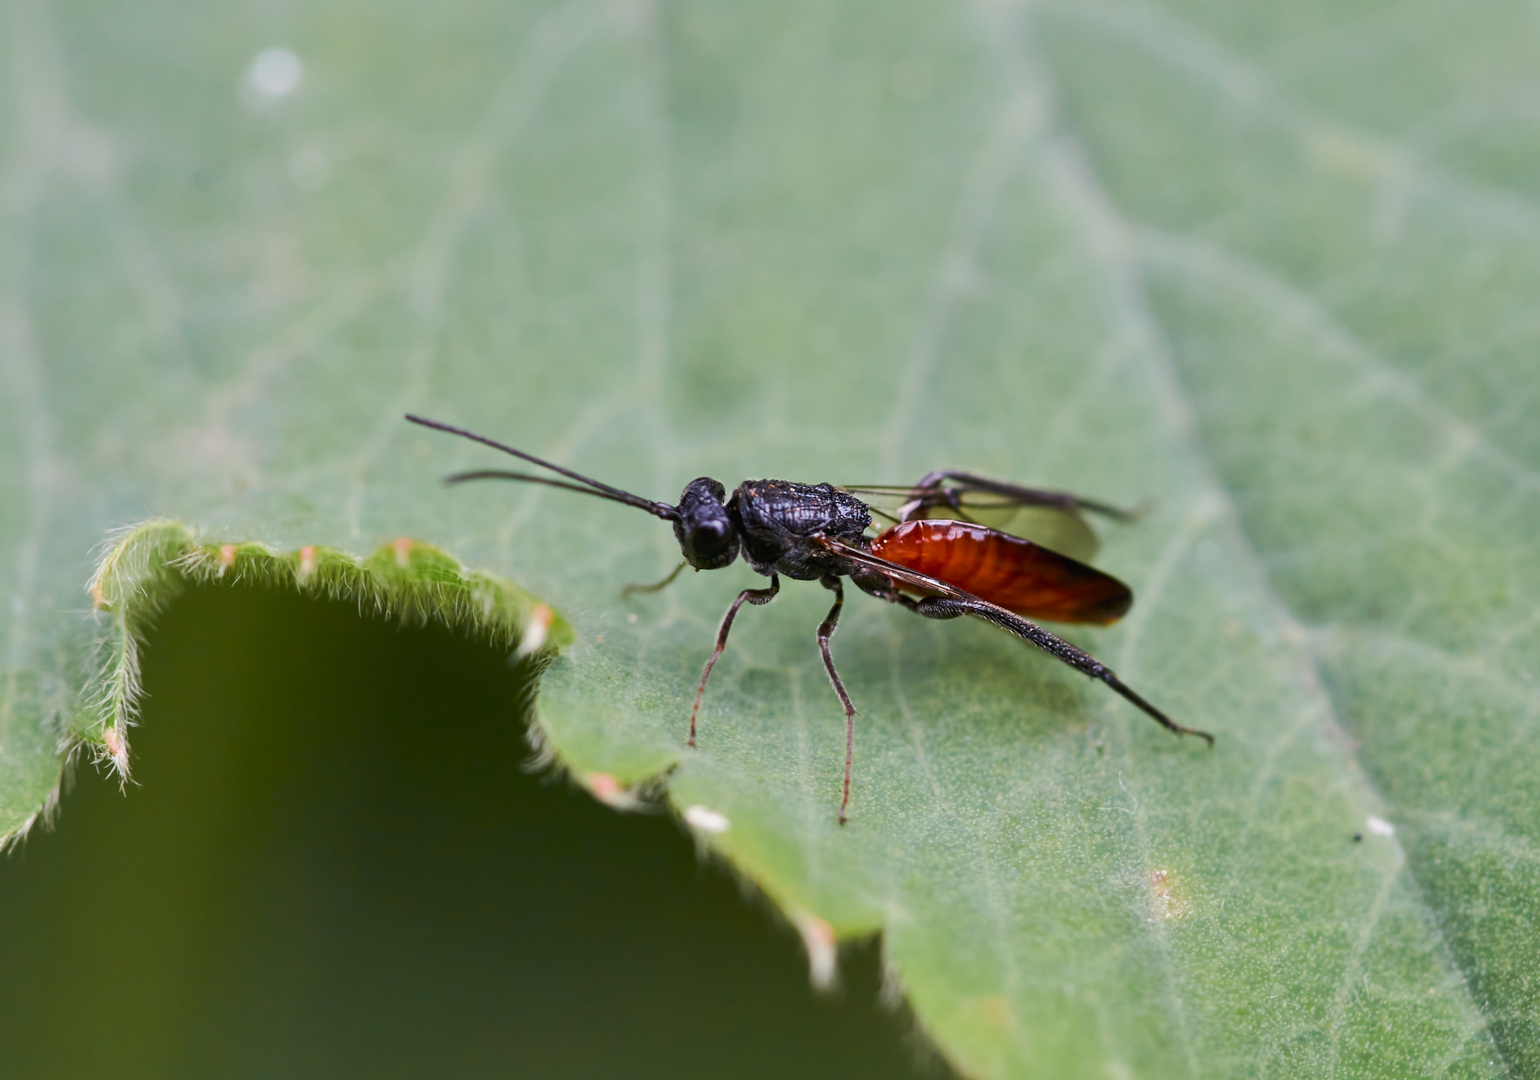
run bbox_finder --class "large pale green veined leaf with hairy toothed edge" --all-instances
[0,0,1540,1077]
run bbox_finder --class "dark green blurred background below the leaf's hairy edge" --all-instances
[0,589,942,1078]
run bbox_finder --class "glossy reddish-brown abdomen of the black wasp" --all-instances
[872,519,1133,624]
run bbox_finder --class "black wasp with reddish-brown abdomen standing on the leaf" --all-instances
[407,414,1214,824]
